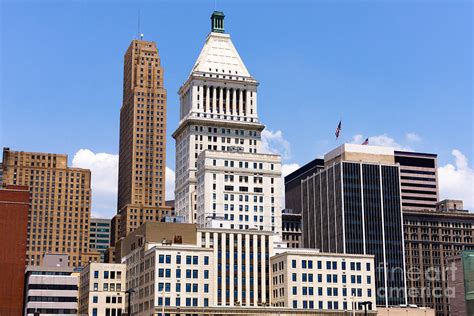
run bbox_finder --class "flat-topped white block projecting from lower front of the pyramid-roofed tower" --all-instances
[196,150,282,233]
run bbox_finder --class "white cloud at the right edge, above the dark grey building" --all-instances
[438,149,474,211]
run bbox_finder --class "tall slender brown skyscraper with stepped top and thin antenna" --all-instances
[112,40,171,239]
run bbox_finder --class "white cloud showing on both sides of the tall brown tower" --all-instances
[72,149,175,218]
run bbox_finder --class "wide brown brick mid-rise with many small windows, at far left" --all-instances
[3,148,91,267]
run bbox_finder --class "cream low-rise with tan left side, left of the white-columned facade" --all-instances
[124,242,214,315]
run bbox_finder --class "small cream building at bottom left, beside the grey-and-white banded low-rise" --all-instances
[79,262,126,316]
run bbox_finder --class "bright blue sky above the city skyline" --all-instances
[0,0,474,215]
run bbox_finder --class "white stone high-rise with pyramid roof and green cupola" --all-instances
[173,12,282,232]
